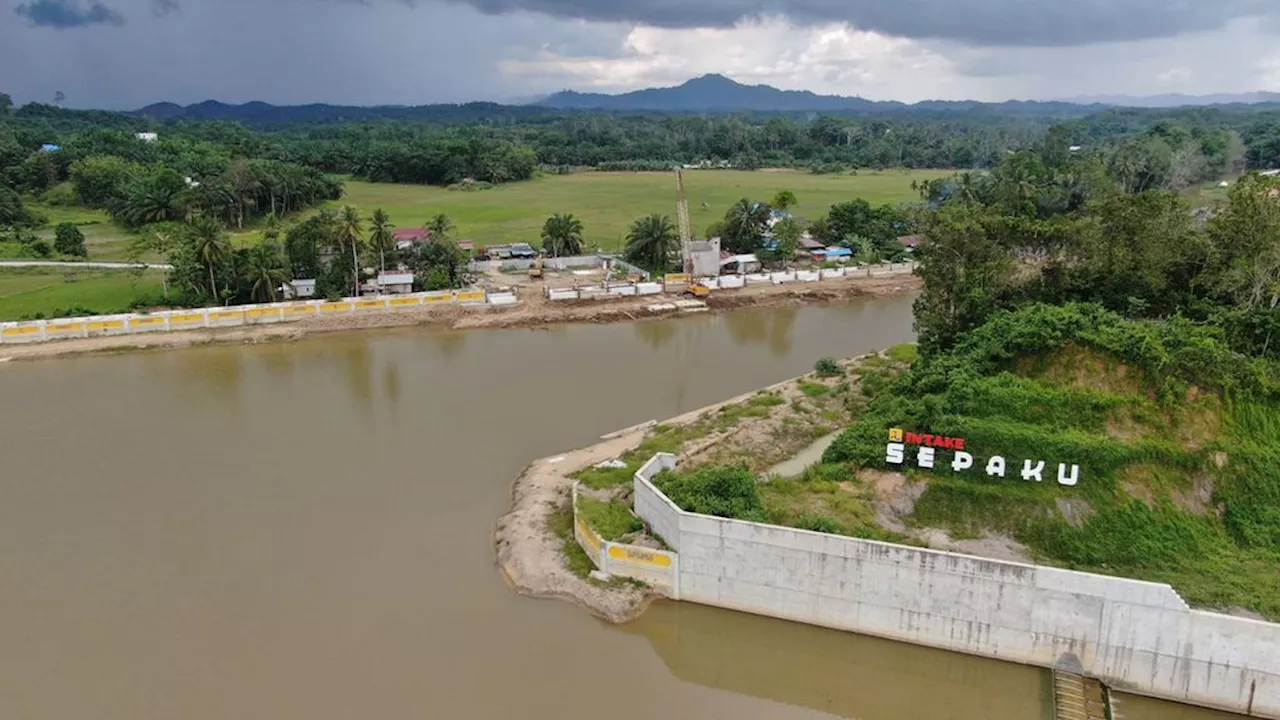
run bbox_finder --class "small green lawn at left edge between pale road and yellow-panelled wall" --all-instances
[0,268,164,320]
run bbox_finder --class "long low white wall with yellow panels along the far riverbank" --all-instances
[0,288,494,345]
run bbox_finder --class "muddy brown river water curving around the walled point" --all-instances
[0,297,1226,720]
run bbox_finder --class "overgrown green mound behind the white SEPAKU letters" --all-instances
[823,299,1280,619]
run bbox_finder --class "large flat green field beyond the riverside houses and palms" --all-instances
[330,170,950,250]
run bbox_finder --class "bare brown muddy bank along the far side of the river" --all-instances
[0,270,920,363]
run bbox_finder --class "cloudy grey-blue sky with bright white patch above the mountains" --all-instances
[0,0,1280,109]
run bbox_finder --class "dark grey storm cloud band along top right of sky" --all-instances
[451,0,1280,46]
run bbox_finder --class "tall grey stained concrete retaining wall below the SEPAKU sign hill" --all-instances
[635,454,1280,719]
